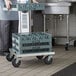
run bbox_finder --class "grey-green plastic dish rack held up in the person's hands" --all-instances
[17,3,45,11]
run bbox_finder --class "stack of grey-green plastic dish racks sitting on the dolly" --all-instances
[12,32,52,54]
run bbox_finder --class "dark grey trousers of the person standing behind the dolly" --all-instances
[0,20,18,51]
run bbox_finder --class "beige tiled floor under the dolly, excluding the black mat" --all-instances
[0,47,76,76]
